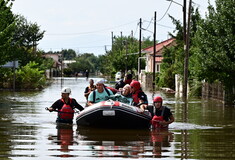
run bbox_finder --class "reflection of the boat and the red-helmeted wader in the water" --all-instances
[74,128,173,158]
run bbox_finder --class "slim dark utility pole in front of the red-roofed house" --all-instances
[153,11,157,93]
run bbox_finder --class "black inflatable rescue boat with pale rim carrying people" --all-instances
[76,100,151,128]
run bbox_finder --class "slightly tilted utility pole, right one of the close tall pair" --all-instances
[183,0,192,100]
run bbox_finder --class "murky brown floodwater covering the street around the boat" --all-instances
[0,78,235,160]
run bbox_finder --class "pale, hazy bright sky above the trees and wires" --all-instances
[12,0,214,55]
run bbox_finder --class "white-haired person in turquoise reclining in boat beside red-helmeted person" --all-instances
[109,84,133,105]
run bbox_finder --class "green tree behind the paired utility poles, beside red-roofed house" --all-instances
[157,8,201,88]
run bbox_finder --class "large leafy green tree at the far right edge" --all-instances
[193,0,235,101]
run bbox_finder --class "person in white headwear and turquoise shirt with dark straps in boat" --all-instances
[87,80,113,106]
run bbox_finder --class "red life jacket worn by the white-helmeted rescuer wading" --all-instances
[58,98,74,120]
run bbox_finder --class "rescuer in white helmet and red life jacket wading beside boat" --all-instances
[48,87,84,123]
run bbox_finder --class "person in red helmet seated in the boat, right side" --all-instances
[130,80,148,112]
